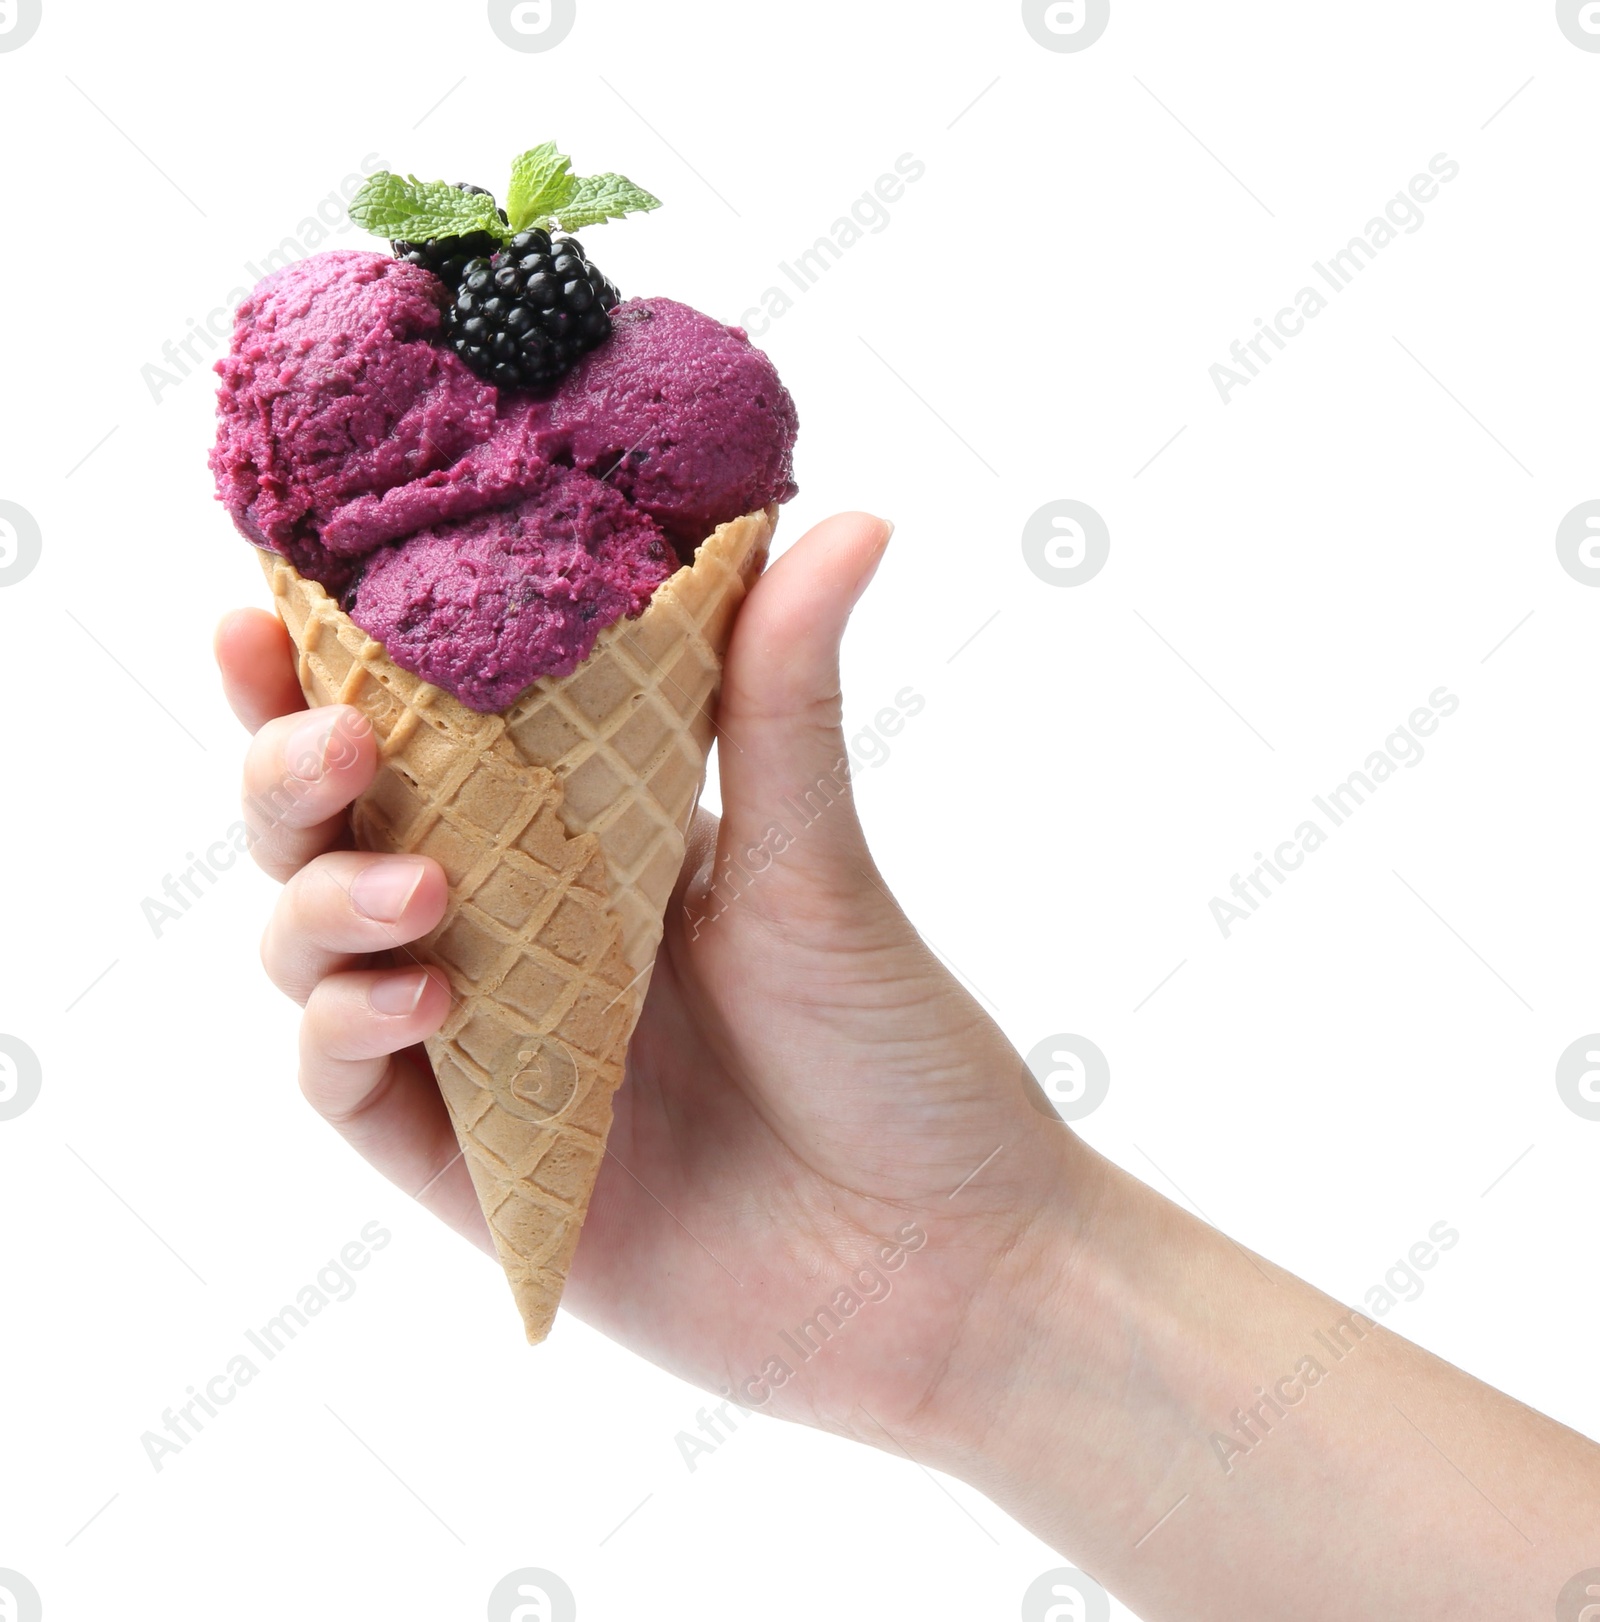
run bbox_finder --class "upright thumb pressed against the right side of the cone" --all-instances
[717,513,894,890]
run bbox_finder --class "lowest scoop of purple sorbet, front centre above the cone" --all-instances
[349,467,678,710]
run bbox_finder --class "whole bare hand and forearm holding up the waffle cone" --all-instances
[217,514,1600,1622]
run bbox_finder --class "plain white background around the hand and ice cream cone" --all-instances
[0,0,1600,1622]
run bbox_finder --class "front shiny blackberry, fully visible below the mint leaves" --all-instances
[445,230,622,389]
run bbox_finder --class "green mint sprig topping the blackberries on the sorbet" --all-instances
[351,141,660,243]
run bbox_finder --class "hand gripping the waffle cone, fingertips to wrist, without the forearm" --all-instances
[217,514,1073,1447]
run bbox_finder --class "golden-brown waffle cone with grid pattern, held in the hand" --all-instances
[261,508,777,1343]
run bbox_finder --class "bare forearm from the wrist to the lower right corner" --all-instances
[941,1140,1600,1622]
